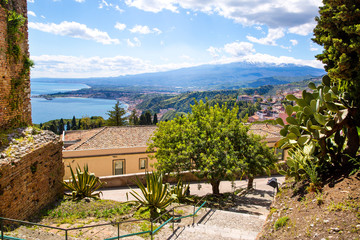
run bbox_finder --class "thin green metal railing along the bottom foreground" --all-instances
[0,197,206,240]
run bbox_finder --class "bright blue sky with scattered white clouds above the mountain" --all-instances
[28,0,322,78]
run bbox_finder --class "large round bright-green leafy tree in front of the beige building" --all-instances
[148,101,271,194]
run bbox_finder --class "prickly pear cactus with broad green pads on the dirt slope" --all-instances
[276,75,359,172]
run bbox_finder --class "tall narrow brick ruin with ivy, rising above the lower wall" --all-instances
[0,0,31,131]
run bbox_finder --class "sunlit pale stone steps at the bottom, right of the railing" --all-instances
[168,209,266,240]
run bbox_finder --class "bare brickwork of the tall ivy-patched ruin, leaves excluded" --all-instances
[0,0,31,131]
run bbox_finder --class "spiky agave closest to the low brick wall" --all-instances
[62,165,105,200]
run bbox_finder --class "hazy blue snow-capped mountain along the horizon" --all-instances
[32,62,325,91]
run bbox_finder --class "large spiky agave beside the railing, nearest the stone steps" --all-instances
[130,172,174,219]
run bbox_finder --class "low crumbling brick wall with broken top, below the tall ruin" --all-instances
[0,133,64,219]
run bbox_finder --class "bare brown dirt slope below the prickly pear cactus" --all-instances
[259,173,360,240]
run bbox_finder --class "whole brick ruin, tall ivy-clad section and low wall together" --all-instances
[0,0,64,220]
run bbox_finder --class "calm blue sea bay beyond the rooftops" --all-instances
[31,80,118,124]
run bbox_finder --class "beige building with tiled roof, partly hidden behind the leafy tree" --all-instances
[63,124,286,179]
